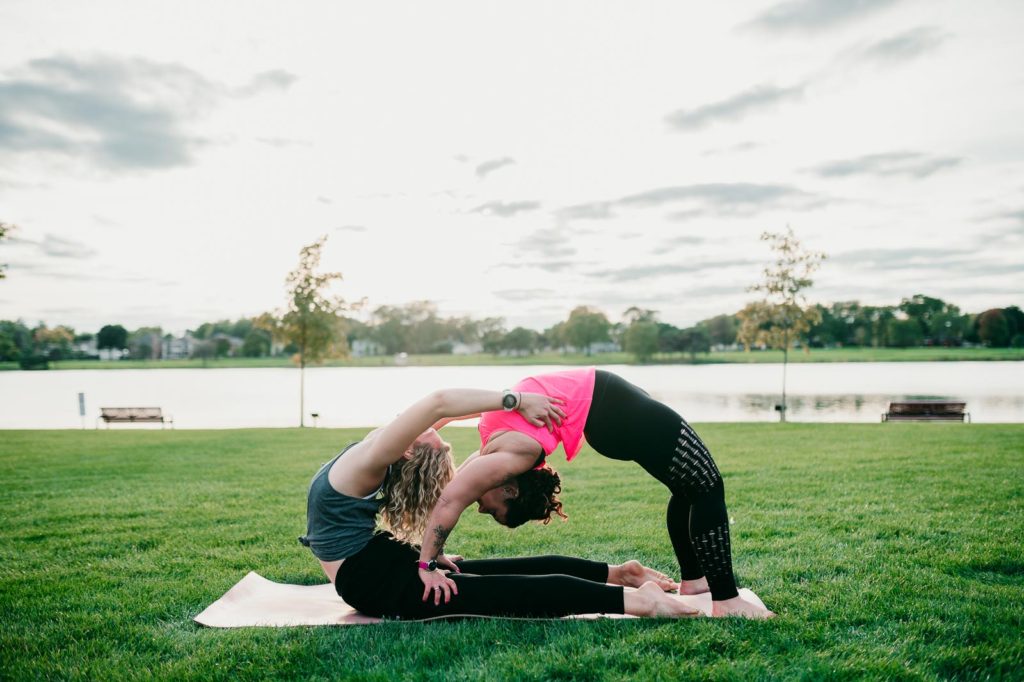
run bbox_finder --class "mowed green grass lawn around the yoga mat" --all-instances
[0,424,1024,681]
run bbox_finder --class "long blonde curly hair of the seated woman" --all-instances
[381,442,455,543]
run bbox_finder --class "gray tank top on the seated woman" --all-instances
[299,442,391,561]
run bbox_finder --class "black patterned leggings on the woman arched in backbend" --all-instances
[584,370,738,600]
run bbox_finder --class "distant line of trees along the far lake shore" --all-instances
[0,294,1024,366]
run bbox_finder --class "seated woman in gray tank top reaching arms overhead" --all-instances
[299,389,697,619]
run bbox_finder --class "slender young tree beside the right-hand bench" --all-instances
[737,226,826,422]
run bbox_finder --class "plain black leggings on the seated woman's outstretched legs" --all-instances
[335,532,624,620]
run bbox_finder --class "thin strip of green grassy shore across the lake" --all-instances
[0,347,1024,371]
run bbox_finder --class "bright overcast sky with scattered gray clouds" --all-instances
[0,0,1024,331]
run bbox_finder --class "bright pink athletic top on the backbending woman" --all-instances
[477,367,595,462]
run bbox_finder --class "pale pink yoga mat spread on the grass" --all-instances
[195,571,764,628]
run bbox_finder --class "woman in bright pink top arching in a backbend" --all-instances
[420,368,773,617]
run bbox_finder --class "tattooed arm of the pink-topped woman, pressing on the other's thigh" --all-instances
[420,453,537,604]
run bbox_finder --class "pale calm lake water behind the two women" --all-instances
[0,361,1024,429]
